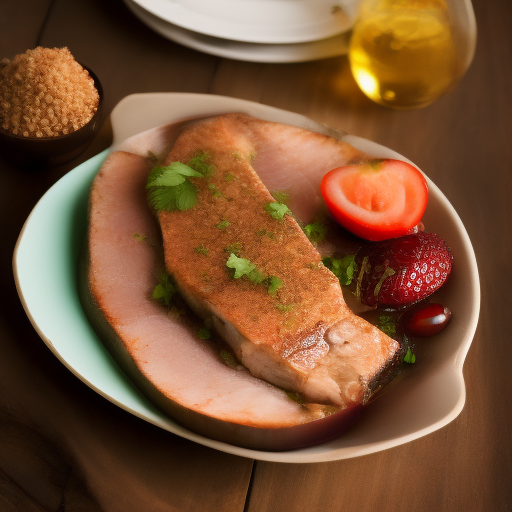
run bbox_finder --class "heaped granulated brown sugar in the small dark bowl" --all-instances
[0,46,99,137]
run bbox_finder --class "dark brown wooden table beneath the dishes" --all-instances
[0,0,512,512]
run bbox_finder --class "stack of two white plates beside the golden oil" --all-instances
[124,0,359,63]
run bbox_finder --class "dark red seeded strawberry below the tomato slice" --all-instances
[355,232,453,308]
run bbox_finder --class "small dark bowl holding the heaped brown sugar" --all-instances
[0,64,103,171]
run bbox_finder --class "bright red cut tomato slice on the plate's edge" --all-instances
[321,159,428,240]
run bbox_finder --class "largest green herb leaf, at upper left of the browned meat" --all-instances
[146,162,203,211]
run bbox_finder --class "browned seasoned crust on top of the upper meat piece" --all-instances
[159,114,348,356]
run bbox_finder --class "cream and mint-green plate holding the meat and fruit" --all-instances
[13,93,480,463]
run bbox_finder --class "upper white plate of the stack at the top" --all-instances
[128,0,359,44]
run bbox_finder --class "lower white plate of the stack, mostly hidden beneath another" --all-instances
[124,0,350,64]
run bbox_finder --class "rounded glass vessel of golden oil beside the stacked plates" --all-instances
[349,0,459,109]
